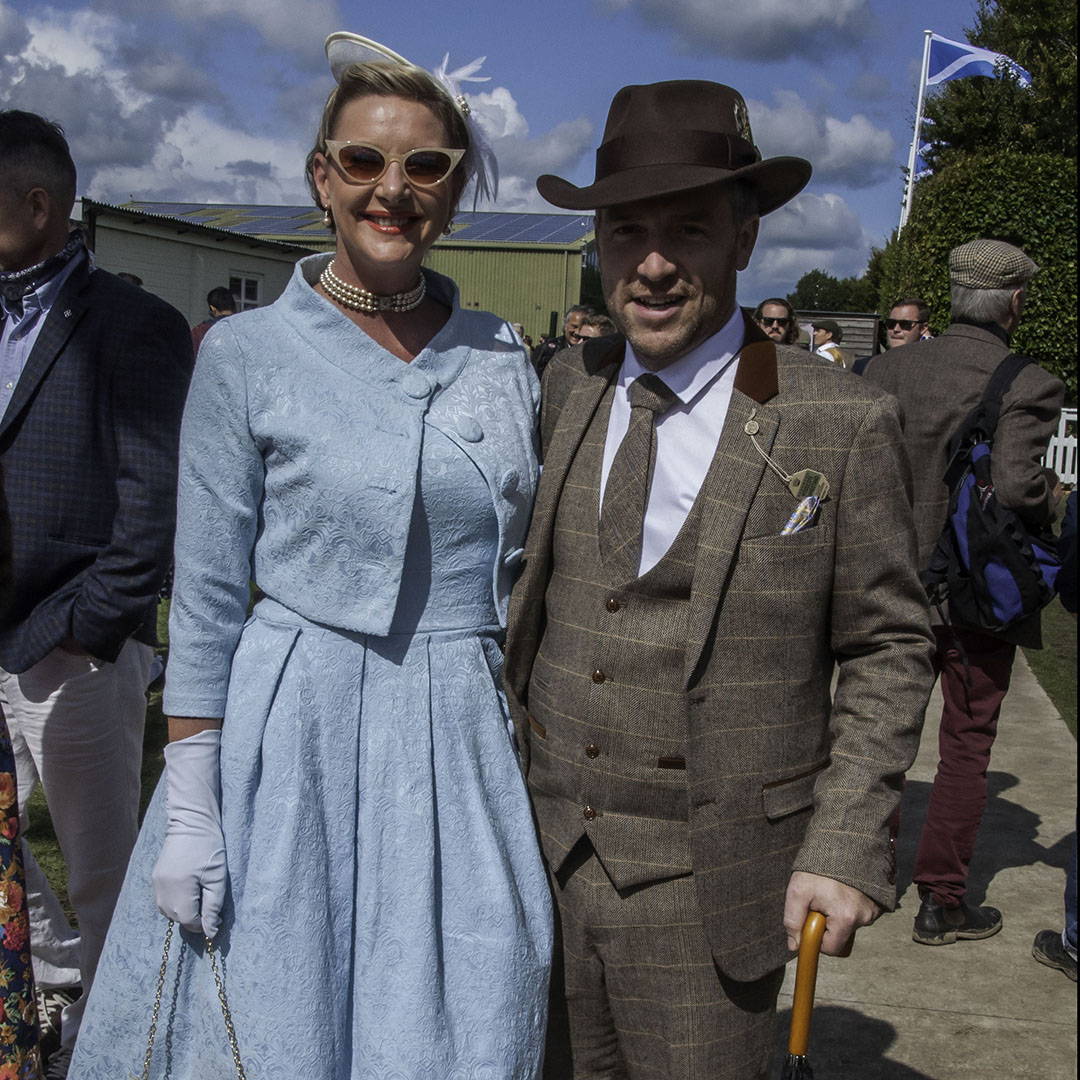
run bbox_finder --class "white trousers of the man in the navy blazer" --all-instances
[0,640,153,1045]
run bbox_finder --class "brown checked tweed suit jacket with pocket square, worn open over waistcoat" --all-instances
[504,321,933,980]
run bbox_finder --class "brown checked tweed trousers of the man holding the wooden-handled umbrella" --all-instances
[544,837,784,1080]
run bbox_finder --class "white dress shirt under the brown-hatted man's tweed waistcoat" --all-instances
[600,308,743,575]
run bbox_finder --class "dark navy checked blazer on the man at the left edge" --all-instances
[0,264,192,673]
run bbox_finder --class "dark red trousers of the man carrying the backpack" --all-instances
[914,626,1016,907]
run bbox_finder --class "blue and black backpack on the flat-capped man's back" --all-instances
[920,353,1061,633]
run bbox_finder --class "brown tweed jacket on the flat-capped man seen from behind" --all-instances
[863,323,1065,648]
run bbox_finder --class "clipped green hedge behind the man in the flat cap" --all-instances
[880,153,1077,404]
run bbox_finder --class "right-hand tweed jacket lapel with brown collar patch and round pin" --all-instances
[684,327,780,687]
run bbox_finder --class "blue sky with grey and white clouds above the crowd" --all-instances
[0,0,975,302]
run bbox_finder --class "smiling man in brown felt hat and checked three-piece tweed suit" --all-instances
[505,82,931,1080]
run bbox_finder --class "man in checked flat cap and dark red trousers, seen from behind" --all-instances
[865,240,1064,945]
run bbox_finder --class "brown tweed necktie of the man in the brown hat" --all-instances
[599,374,676,581]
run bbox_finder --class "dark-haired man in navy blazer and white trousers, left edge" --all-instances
[0,110,192,1077]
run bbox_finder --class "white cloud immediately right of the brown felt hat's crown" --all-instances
[747,90,900,188]
